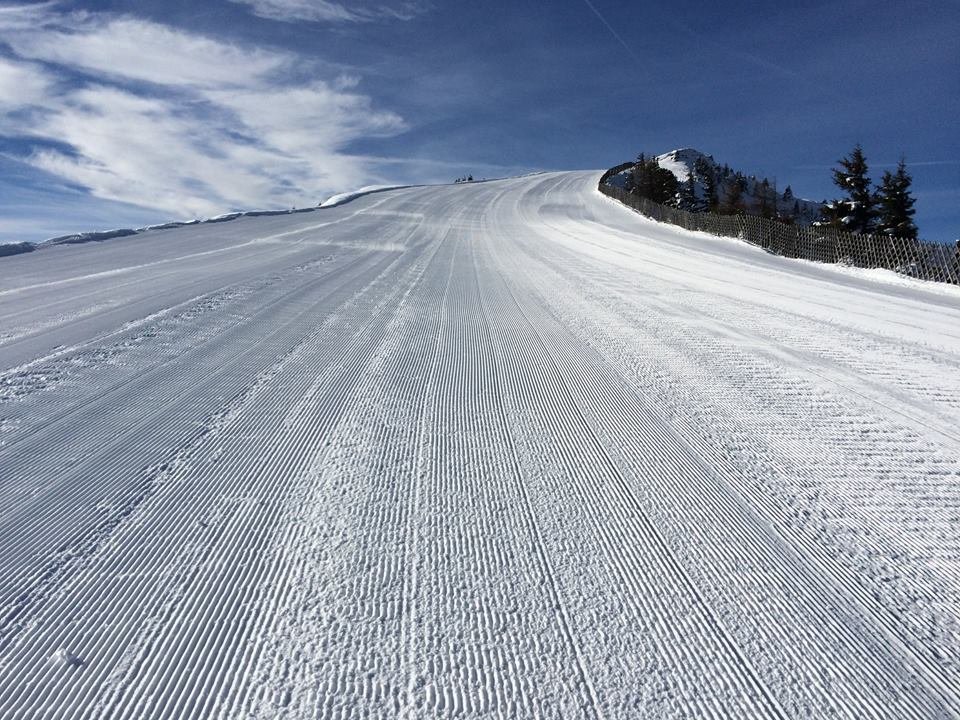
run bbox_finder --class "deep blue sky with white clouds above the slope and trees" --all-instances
[0,0,960,241]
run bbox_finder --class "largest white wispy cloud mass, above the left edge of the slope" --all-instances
[0,4,406,217]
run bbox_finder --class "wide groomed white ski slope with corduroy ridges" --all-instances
[0,173,960,720]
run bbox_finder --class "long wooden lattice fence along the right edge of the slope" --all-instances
[600,182,960,284]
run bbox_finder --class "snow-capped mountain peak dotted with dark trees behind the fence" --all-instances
[607,148,823,225]
